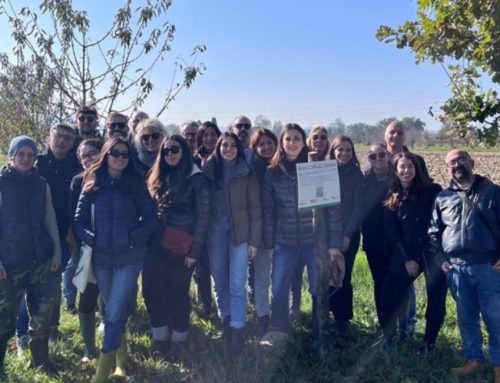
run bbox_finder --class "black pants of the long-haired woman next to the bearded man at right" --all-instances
[381,265,447,343]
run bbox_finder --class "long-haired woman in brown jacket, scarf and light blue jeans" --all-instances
[203,132,262,359]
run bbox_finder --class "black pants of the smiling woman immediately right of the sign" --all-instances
[330,231,360,322]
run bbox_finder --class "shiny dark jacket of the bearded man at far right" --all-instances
[429,175,500,265]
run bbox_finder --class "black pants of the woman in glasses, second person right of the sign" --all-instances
[363,237,391,323]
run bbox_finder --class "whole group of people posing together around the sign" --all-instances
[0,106,500,383]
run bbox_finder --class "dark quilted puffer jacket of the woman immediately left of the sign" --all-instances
[262,159,314,249]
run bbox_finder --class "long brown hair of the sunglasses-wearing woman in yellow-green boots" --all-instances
[83,137,138,193]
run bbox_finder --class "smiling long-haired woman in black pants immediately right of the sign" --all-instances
[328,135,363,347]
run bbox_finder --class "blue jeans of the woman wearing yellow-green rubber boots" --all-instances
[94,262,142,353]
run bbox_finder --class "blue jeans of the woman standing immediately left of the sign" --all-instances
[271,245,318,332]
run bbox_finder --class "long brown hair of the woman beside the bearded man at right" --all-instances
[384,152,428,211]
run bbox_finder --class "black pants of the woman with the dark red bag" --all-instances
[142,255,193,332]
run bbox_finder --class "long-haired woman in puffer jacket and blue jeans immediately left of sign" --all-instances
[262,124,342,347]
